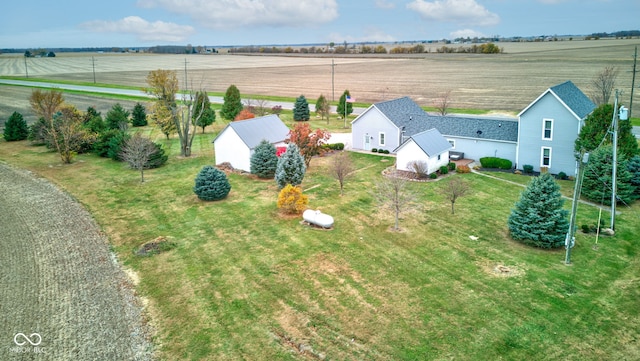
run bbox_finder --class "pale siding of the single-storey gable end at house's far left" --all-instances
[351,106,400,152]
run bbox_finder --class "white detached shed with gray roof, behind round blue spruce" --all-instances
[213,114,289,172]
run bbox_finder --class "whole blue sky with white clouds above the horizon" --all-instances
[0,0,640,48]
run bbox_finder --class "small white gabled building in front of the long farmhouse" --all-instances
[394,128,452,174]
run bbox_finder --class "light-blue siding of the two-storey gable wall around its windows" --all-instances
[517,92,580,175]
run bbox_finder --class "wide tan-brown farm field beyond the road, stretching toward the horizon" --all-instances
[0,39,640,113]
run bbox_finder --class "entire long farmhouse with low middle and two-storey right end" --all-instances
[351,81,595,175]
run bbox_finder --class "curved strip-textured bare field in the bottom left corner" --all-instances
[0,163,152,360]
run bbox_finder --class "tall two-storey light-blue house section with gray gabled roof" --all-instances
[516,81,596,175]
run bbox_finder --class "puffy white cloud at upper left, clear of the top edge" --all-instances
[80,16,194,42]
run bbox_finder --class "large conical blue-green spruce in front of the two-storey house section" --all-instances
[507,173,569,248]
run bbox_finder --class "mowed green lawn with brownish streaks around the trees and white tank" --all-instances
[0,123,640,360]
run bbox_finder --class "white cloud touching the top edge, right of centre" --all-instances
[407,0,500,26]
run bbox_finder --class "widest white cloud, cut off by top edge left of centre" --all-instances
[138,0,338,29]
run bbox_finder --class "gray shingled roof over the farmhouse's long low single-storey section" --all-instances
[373,97,518,142]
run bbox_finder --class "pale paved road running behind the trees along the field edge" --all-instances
[0,79,366,115]
